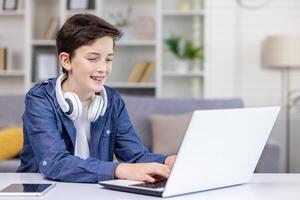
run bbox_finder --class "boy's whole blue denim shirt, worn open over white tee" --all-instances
[17,79,166,182]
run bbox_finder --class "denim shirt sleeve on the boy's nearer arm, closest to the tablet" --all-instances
[23,92,119,182]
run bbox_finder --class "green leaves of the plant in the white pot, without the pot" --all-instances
[164,36,203,60]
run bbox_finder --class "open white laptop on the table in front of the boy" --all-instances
[99,107,280,197]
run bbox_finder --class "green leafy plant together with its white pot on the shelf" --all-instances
[164,36,203,72]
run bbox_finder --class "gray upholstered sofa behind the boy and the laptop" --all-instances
[0,95,280,172]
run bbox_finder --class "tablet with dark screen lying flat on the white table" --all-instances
[0,183,54,195]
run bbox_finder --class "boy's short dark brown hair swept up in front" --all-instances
[56,14,122,73]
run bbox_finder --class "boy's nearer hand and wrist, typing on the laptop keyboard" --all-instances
[115,163,170,183]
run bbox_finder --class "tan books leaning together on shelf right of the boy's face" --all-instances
[128,60,155,83]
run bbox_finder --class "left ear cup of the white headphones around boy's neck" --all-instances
[64,92,82,121]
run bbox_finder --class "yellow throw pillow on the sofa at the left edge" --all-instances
[0,127,23,160]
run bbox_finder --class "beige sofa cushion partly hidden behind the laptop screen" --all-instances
[150,113,192,155]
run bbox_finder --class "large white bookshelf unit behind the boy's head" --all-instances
[0,0,207,98]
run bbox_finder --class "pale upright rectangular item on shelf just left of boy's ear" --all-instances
[35,53,58,81]
